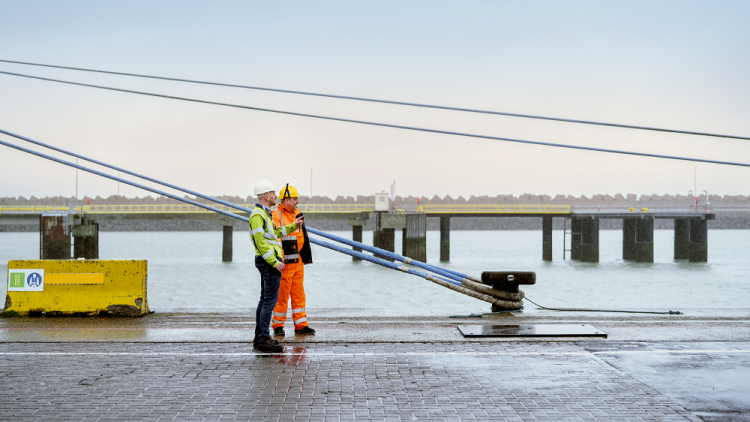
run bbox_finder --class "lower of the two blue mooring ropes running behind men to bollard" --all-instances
[0,140,506,303]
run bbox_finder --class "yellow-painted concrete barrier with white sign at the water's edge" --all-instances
[3,260,148,316]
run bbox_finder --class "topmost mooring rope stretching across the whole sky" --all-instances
[0,60,750,140]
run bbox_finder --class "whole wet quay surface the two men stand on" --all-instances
[0,308,750,421]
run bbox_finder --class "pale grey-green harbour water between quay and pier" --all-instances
[0,230,750,312]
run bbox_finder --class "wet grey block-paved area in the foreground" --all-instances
[0,342,701,422]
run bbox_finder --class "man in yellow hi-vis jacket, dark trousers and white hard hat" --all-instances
[250,180,302,353]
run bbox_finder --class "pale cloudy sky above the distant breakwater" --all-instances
[0,0,750,198]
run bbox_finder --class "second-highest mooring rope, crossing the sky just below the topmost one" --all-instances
[0,71,750,167]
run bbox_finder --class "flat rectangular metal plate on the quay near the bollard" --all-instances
[458,324,607,338]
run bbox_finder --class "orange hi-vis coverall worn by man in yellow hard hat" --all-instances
[271,205,307,330]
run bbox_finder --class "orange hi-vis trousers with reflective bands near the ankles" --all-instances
[271,261,307,330]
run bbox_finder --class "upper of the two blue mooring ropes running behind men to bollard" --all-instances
[0,129,476,282]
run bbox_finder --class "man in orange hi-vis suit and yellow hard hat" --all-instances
[271,183,315,336]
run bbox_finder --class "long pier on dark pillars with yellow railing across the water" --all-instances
[0,204,715,262]
